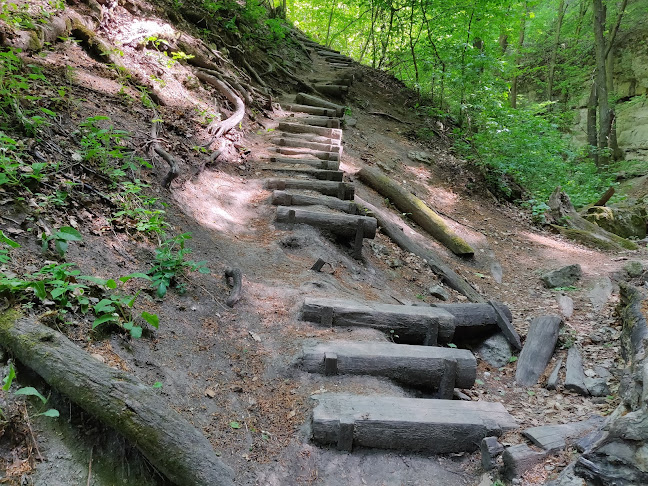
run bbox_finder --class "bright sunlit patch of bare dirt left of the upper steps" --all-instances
[174,171,268,235]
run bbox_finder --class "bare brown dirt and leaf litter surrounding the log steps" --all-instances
[0,1,648,486]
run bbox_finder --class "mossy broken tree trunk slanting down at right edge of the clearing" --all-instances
[549,187,639,251]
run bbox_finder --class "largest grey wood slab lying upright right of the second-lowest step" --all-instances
[515,314,562,386]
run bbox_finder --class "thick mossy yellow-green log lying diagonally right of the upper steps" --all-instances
[358,166,475,256]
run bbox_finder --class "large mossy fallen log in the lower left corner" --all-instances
[0,314,233,486]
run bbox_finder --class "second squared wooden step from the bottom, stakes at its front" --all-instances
[301,341,477,392]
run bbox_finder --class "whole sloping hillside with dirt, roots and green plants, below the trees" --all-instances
[0,0,648,485]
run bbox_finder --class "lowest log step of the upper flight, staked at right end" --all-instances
[277,206,378,239]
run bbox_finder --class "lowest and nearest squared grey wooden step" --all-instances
[312,393,517,454]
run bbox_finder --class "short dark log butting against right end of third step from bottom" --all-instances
[432,303,513,341]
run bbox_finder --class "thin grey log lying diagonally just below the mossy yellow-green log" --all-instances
[355,196,486,302]
